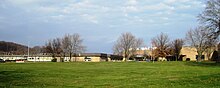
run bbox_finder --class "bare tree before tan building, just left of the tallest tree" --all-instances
[186,26,210,62]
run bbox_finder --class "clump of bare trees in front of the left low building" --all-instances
[44,33,86,61]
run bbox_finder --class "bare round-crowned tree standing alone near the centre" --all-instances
[113,33,143,61]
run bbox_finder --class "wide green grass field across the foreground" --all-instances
[0,62,220,88]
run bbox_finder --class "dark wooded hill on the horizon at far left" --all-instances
[0,41,28,55]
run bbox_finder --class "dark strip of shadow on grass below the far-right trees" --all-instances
[186,61,220,67]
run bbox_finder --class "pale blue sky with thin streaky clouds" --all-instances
[0,0,205,53]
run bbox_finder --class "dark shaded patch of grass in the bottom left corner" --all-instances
[0,70,31,88]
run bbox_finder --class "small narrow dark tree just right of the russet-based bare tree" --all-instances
[171,39,184,61]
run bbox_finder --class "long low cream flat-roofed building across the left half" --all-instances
[0,53,120,62]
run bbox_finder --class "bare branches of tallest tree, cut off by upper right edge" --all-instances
[198,0,220,38]
